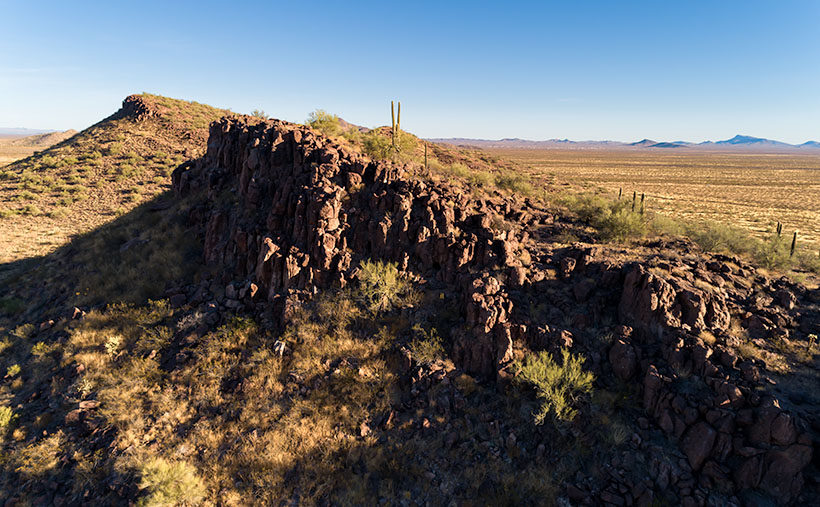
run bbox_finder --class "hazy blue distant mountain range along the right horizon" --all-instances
[428,135,820,153]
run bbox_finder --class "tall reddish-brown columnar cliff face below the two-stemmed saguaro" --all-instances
[173,118,526,375]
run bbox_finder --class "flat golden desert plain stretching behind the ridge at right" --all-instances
[488,150,820,246]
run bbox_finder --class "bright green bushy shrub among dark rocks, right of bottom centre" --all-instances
[513,349,595,424]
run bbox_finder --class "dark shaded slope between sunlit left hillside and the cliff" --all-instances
[0,192,201,325]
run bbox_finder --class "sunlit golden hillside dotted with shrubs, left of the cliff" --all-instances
[0,94,230,262]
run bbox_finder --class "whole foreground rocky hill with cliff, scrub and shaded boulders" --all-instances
[0,102,820,505]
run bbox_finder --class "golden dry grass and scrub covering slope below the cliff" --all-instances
[0,254,561,505]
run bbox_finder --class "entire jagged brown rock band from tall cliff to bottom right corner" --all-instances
[172,118,818,505]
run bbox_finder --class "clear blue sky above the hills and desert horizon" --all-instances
[0,0,820,142]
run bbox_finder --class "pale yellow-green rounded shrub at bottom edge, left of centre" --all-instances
[137,458,206,507]
